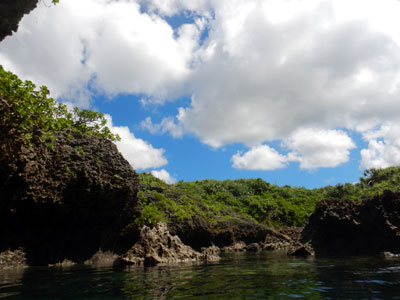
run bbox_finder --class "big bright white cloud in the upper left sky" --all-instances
[0,0,199,106]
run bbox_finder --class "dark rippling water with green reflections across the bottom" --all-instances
[0,252,400,300]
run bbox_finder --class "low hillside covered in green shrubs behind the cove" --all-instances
[136,167,400,228]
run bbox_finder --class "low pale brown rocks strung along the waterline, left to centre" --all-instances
[0,223,301,269]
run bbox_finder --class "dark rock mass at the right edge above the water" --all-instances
[303,191,400,255]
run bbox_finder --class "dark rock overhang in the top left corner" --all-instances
[0,0,38,42]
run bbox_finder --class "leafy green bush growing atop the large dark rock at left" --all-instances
[0,66,120,144]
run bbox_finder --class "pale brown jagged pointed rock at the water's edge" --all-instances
[122,223,218,265]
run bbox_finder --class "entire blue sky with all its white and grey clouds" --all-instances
[0,0,400,188]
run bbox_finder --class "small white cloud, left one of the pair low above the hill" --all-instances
[231,145,288,171]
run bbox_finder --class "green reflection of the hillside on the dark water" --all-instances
[123,253,325,299]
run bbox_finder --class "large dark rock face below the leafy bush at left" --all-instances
[0,131,139,265]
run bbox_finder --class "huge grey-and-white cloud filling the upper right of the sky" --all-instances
[175,1,400,147]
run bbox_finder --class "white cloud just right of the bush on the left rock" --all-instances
[106,115,168,170]
